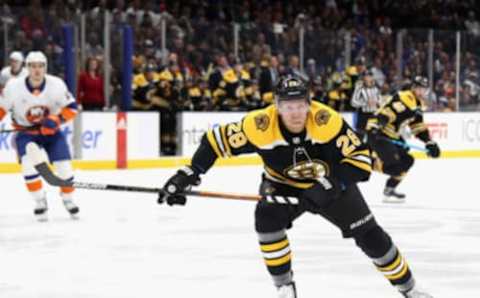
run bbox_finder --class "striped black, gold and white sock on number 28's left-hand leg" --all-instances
[258,230,292,286]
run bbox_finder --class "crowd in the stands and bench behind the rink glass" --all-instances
[0,0,480,114]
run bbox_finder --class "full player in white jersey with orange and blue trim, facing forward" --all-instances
[0,51,79,221]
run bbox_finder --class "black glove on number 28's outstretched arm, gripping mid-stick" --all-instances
[158,167,201,206]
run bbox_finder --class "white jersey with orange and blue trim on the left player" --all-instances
[0,75,77,127]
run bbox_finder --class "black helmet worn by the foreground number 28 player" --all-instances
[275,75,310,102]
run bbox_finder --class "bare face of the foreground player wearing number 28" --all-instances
[278,99,310,133]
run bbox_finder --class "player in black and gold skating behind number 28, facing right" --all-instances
[367,76,440,203]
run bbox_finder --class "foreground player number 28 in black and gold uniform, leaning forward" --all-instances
[159,77,432,298]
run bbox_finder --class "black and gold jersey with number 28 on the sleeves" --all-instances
[192,102,371,189]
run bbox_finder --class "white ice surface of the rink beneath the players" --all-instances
[0,159,480,298]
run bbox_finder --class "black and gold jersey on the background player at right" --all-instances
[367,90,430,142]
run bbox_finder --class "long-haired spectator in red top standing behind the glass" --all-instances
[77,57,105,111]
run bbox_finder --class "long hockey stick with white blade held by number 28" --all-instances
[27,142,298,205]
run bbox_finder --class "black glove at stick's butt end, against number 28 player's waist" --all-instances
[299,178,344,213]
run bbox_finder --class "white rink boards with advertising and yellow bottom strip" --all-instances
[0,112,480,173]
